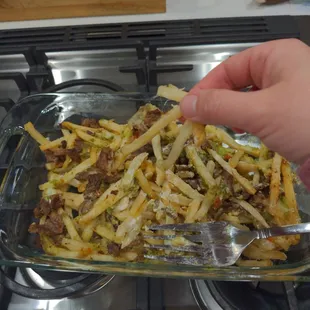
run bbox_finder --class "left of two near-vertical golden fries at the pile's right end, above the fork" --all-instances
[268,153,284,220]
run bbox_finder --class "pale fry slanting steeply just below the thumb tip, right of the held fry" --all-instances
[163,120,193,169]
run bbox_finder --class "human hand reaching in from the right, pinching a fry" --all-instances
[181,39,310,164]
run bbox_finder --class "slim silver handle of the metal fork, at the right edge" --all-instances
[256,223,310,239]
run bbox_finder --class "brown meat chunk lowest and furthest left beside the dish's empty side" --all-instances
[29,212,64,237]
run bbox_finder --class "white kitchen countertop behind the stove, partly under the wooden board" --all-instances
[0,0,310,30]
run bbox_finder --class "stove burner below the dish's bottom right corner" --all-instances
[190,280,310,310]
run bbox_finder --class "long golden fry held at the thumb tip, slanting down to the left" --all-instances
[121,106,182,157]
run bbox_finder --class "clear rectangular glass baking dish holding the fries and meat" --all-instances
[0,93,310,281]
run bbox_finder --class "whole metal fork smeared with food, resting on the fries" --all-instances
[144,222,310,267]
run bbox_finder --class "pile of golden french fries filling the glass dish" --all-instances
[25,85,300,266]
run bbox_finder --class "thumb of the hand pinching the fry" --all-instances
[180,89,270,133]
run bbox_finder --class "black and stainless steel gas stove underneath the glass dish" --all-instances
[0,16,310,310]
